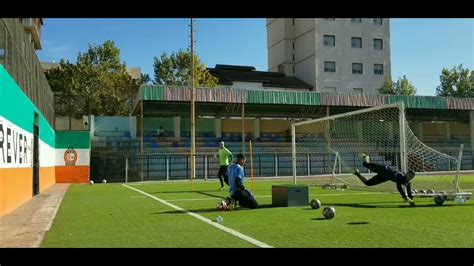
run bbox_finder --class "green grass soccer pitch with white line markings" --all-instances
[41,176,474,248]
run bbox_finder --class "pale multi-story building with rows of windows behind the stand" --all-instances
[267,18,391,94]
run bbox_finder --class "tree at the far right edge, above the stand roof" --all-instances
[436,64,474,97]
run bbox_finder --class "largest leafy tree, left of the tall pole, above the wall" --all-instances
[46,41,142,117]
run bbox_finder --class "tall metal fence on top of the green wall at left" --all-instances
[0,18,54,125]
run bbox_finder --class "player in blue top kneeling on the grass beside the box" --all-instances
[228,153,258,209]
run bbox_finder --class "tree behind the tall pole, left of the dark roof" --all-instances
[153,50,219,88]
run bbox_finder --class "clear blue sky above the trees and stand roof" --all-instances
[38,18,474,95]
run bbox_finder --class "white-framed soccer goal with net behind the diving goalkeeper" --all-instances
[292,103,468,197]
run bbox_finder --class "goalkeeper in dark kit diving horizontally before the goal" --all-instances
[354,154,415,206]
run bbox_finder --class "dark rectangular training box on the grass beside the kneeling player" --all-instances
[272,185,309,207]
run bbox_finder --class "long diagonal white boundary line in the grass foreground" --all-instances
[122,184,272,248]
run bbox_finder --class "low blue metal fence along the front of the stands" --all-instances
[91,152,474,182]
